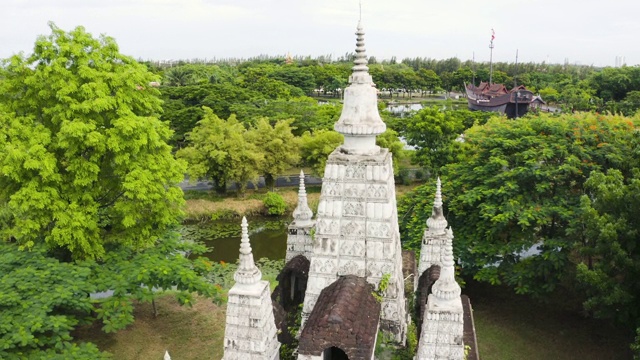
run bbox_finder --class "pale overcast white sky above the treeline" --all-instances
[0,0,640,66]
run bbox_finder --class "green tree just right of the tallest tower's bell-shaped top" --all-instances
[396,106,493,173]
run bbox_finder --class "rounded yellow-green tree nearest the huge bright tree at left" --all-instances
[176,108,264,195]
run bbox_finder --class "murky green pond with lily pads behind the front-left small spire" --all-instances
[181,218,290,263]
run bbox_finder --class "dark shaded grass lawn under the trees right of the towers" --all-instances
[463,282,632,360]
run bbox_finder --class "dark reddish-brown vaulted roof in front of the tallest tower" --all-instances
[298,275,380,360]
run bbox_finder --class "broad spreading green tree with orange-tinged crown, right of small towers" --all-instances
[400,114,634,294]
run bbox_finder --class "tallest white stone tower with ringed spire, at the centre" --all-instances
[302,21,407,343]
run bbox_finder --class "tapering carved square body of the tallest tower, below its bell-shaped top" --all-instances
[303,149,406,342]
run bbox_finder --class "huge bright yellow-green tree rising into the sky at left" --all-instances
[0,25,184,258]
